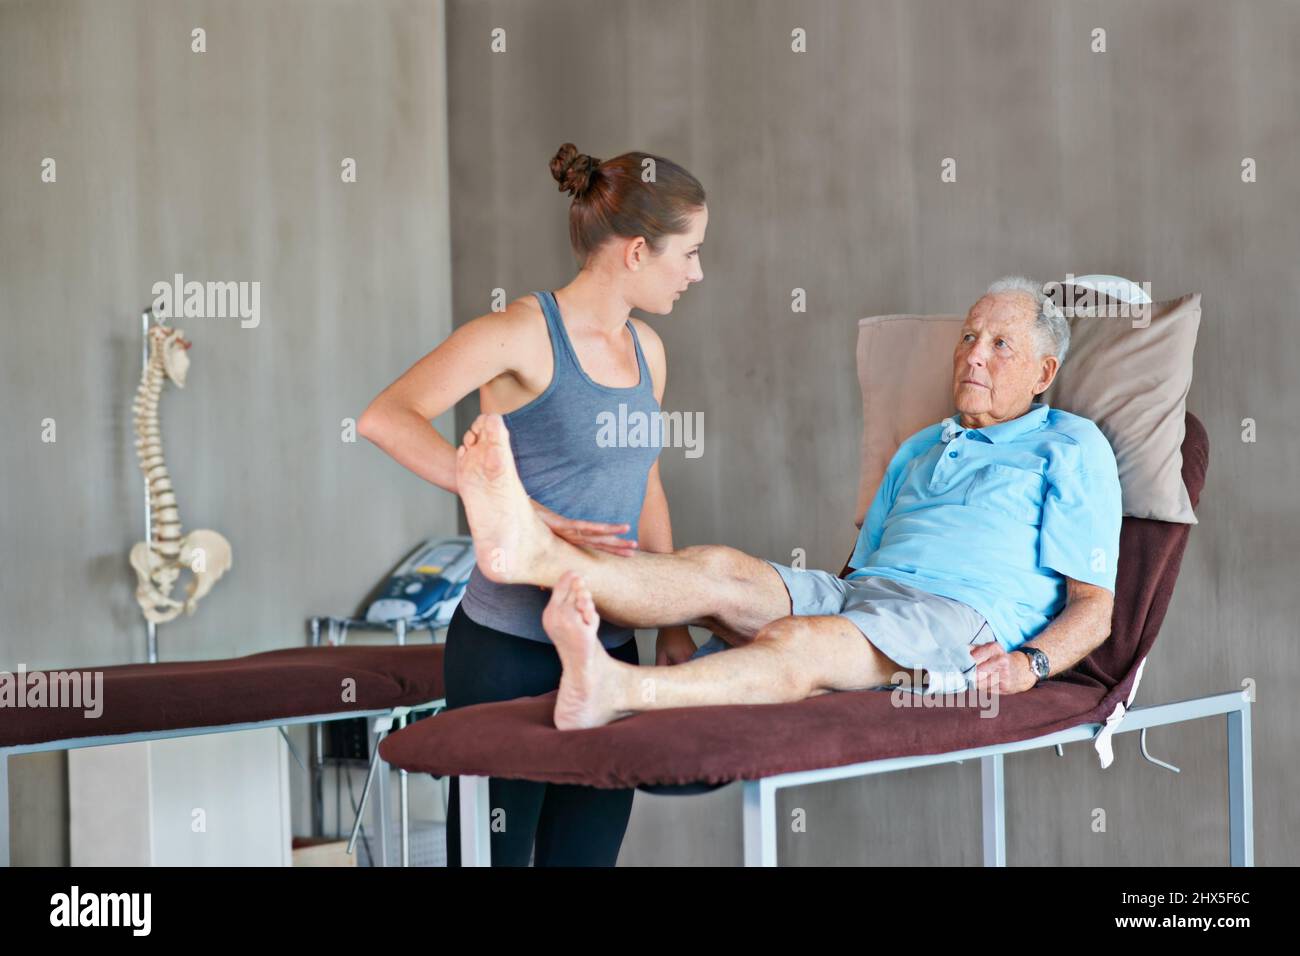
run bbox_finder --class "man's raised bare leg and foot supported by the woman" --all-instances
[456,415,790,637]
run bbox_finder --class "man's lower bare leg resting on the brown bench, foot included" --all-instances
[542,572,904,730]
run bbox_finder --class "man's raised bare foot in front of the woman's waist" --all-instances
[456,415,551,584]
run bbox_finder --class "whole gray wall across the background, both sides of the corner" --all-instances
[0,0,1300,865]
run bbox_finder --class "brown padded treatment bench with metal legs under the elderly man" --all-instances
[380,414,1249,864]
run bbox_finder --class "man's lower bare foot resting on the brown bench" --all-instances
[542,571,621,730]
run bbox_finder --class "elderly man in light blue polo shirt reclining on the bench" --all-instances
[456,277,1121,730]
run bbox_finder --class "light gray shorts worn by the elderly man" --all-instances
[696,562,997,693]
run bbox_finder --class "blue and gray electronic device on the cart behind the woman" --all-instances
[365,537,475,627]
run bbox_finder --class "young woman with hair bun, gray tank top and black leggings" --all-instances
[358,143,709,866]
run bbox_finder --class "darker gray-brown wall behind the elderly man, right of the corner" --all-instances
[447,0,1300,865]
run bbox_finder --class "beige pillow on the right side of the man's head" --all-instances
[1045,293,1201,524]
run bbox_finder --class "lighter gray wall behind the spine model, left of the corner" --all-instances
[0,0,456,864]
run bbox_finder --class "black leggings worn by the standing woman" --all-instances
[433,607,637,866]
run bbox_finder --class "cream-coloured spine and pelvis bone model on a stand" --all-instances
[131,324,230,623]
